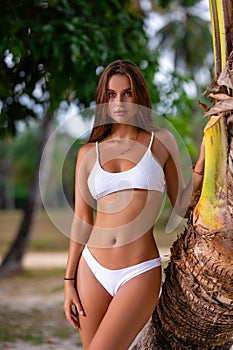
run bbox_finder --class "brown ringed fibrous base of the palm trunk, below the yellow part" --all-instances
[134,222,233,350]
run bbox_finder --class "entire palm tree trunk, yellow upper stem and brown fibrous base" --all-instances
[134,0,233,350]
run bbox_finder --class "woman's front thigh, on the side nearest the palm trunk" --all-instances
[89,267,161,350]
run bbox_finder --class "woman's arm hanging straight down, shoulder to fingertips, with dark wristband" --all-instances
[64,146,93,328]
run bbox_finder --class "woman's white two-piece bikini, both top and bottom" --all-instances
[82,132,165,296]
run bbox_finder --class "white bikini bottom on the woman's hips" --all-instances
[82,246,161,296]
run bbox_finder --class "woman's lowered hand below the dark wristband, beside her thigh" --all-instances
[64,281,84,329]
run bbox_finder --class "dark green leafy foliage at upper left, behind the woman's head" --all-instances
[0,0,157,136]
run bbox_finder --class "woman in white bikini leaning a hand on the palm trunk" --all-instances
[64,60,204,350]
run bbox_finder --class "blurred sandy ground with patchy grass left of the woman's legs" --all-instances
[0,252,158,350]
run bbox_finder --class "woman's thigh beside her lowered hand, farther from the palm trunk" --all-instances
[78,257,112,349]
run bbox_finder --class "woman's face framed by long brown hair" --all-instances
[108,74,136,123]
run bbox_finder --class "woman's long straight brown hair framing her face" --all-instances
[88,60,153,142]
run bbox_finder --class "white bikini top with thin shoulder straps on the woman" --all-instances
[87,132,165,200]
